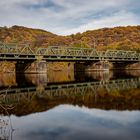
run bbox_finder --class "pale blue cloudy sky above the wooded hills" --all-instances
[0,0,140,35]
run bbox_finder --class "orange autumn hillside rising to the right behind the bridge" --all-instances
[74,26,140,50]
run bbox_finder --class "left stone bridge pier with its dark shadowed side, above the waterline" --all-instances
[16,60,47,73]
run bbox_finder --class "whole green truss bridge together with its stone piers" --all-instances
[0,42,140,73]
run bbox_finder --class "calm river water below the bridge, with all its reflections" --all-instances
[0,71,140,140]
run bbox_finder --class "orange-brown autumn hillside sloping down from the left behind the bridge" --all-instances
[0,26,70,47]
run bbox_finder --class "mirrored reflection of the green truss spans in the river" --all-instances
[0,78,140,104]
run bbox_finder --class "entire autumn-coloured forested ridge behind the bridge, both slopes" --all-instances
[0,26,140,51]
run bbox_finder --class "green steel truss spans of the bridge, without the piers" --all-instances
[0,42,140,62]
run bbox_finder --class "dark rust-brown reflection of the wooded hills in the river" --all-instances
[1,78,140,115]
